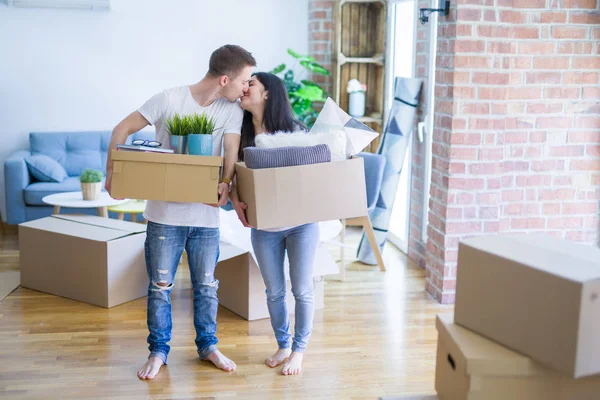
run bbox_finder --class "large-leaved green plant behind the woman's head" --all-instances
[269,49,330,128]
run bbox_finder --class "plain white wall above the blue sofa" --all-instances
[0,0,308,220]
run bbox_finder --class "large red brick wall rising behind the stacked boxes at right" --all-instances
[426,0,600,303]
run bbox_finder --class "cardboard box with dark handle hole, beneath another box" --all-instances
[435,315,600,400]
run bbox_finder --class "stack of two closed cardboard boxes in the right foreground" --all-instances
[435,234,600,400]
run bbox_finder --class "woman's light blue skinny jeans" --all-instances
[252,223,319,352]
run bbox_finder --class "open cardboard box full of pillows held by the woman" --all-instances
[235,157,367,229]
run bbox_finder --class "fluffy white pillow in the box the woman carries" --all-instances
[254,130,347,161]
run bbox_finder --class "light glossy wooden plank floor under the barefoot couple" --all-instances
[0,228,452,399]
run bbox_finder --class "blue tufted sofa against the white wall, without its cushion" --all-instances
[4,131,154,224]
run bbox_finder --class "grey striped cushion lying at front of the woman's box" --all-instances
[244,144,331,169]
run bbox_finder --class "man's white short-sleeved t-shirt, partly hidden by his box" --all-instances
[138,86,244,228]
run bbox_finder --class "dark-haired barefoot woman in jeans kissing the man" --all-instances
[231,72,319,375]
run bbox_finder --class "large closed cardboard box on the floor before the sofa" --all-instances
[19,215,148,308]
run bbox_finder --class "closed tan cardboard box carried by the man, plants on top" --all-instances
[111,150,223,204]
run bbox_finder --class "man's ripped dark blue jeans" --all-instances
[145,221,219,364]
